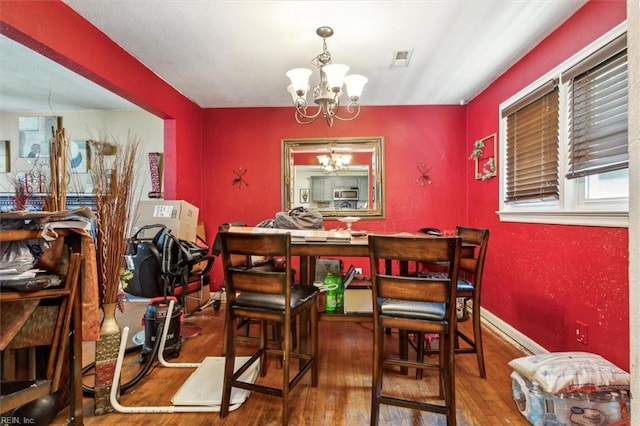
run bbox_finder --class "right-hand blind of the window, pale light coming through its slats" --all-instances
[561,35,629,179]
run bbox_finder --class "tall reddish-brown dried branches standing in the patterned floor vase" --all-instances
[91,135,140,303]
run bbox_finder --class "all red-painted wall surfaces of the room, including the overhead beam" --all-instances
[0,0,629,369]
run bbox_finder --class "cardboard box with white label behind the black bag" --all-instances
[134,200,199,242]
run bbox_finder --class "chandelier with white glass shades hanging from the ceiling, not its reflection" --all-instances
[286,27,368,127]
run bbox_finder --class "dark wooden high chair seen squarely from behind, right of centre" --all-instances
[369,235,461,426]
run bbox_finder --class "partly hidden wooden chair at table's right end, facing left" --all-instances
[455,226,489,378]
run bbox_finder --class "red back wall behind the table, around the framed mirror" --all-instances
[200,106,473,288]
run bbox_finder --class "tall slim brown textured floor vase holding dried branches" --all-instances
[94,303,121,415]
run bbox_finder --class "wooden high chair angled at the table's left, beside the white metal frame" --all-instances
[220,232,318,425]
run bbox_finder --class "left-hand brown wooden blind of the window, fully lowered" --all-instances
[502,81,559,202]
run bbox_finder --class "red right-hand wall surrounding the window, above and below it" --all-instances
[467,1,629,371]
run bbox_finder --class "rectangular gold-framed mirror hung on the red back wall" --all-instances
[281,137,384,219]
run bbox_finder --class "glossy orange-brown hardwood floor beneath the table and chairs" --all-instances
[54,303,528,426]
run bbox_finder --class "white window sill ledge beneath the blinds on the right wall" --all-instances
[497,211,629,228]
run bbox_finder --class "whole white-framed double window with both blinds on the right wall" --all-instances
[498,23,629,226]
